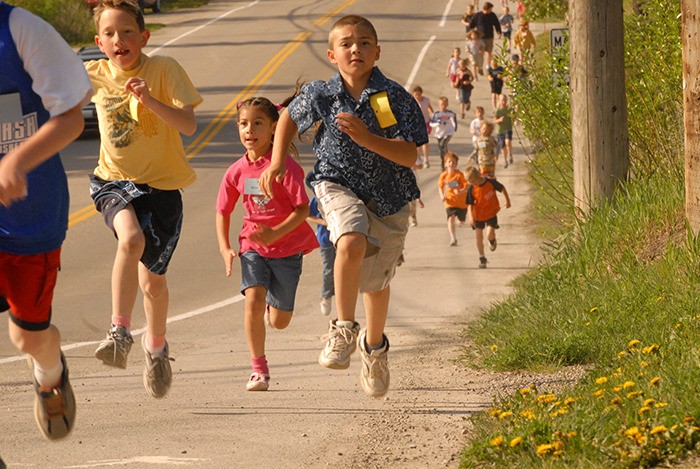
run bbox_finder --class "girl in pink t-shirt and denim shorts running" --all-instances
[216,98,318,391]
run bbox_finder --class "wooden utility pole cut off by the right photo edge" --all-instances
[681,0,700,234]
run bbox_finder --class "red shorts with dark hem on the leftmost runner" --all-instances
[0,248,61,331]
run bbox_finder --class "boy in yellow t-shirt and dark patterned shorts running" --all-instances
[85,0,202,398]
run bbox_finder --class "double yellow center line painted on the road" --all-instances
[68,0,356,228]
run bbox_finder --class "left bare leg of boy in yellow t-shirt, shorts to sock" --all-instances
[112,205,146,317]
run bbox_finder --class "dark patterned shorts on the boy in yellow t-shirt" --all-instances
[90,175,183,275]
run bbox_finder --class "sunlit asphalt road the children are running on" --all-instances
[0,0,536,468]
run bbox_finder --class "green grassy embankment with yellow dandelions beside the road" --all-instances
[461,0,700,468]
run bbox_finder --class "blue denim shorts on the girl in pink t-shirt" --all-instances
[239,250,303,313]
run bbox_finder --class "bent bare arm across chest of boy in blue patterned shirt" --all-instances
[335,112,416,168]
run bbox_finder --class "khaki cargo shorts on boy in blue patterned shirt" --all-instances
[314,181,409,292]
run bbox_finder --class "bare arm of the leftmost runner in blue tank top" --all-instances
[0,105,85,207]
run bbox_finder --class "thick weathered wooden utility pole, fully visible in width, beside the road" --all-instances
[569,0,629,215]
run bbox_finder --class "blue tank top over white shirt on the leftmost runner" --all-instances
[0,2,68,254]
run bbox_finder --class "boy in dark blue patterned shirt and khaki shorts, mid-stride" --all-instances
[260,15,428,397]
